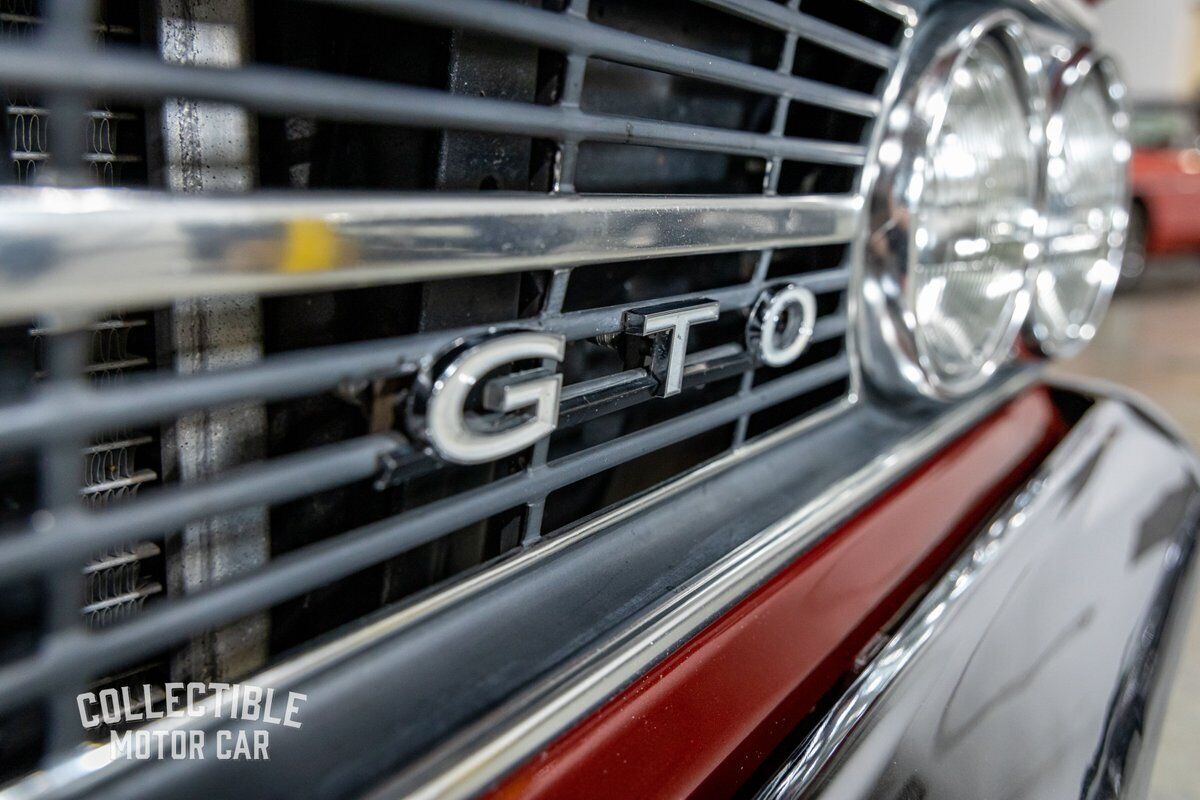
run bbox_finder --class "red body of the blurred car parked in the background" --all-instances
[1133,148,1200,254]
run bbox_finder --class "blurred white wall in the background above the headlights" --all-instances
[1096,0,1198,100]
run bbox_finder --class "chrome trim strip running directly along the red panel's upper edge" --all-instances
[373,371,1037,800]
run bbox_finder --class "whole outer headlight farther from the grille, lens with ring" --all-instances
[1030,59,1129,355]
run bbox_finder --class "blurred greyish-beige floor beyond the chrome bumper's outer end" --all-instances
[1062,261,1200,800]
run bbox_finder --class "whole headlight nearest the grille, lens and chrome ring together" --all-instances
[858,12,1042,398]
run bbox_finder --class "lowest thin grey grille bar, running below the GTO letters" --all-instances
[0,357,850,710]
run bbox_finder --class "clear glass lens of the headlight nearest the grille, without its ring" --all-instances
[906,38,1037,393]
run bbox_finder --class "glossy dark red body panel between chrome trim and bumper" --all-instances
[492,389,1067,800]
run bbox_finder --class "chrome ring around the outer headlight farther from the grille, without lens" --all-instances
[1024,50,1132,357]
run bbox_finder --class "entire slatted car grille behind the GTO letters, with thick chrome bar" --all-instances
[0,0,906,777]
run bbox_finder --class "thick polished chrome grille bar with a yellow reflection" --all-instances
[0,190,862,319]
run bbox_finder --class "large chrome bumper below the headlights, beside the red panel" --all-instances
[757,384,1200,800]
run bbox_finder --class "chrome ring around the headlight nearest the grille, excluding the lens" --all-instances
[852,10,1046,401]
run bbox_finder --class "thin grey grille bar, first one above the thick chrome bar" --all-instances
[0,46,877,160]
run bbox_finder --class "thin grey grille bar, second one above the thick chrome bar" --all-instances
[336,0,880,116]
